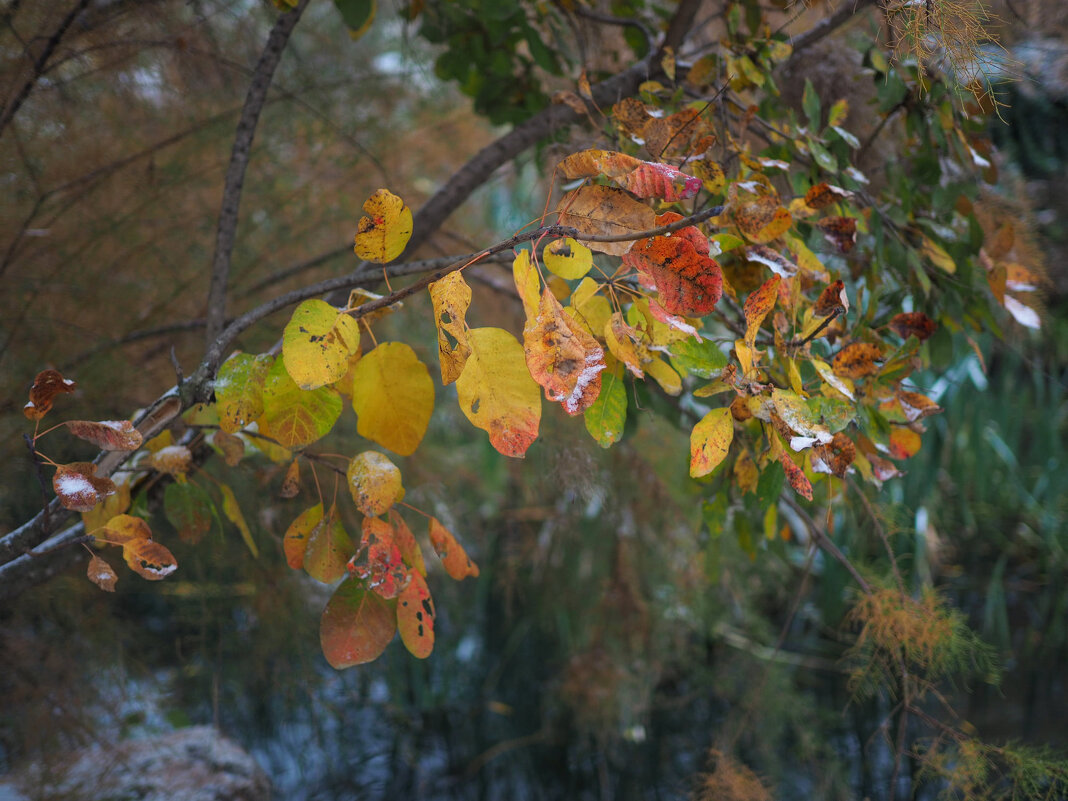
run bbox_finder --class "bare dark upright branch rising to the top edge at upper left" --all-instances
[207,0,309,350]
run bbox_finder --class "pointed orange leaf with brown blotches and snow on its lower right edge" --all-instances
[523,288,604,415]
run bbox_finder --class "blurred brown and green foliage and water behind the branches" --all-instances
[0,0,1068,800]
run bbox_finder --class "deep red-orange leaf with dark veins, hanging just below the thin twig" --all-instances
[623,229,723,317]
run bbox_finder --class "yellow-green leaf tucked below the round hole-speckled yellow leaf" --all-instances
[258,359,342,447]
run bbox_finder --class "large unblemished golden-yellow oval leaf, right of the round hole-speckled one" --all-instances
[352,342,434,456]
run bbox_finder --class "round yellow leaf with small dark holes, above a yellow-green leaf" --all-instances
[282,299,360,390]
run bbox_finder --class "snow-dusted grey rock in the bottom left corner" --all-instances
[0,726,270,801]
